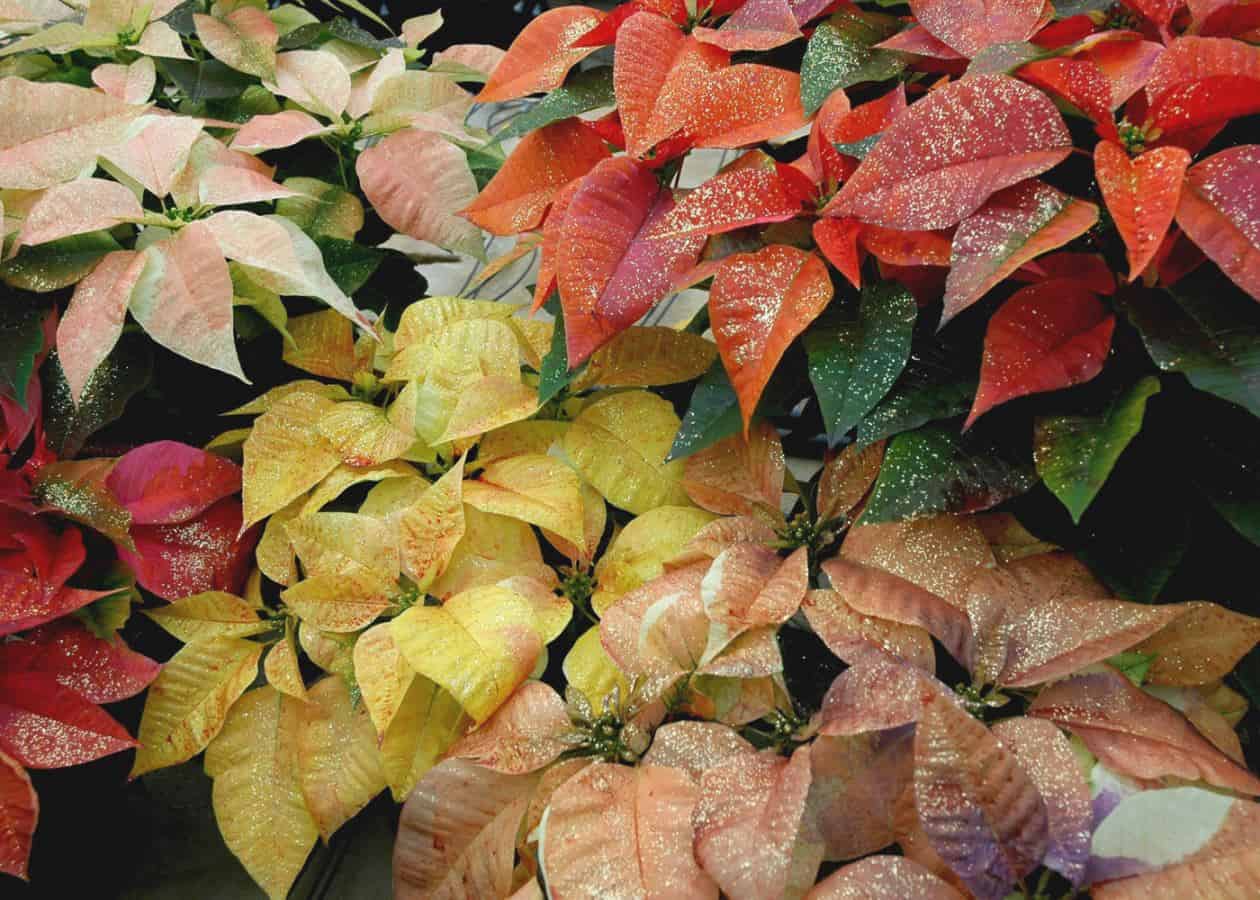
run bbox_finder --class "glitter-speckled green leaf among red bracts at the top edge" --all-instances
[800,6,906,115]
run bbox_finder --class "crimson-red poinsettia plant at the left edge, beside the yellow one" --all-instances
[0,305,256,877]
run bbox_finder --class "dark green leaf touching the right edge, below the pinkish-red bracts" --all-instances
[1120,266,1260,416]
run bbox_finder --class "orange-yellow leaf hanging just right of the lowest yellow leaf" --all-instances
[297,677,386,841]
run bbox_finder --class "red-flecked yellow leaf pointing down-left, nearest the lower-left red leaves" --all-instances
[131,638,262,778]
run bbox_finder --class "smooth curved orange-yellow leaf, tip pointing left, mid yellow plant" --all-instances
[464,451,586,543]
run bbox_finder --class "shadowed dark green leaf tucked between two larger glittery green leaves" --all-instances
[857,344,977,446]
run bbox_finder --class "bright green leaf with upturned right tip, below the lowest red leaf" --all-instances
[1033,376,1159,523]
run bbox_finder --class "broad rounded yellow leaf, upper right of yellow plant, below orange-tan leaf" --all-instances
[564,391,690,514]
